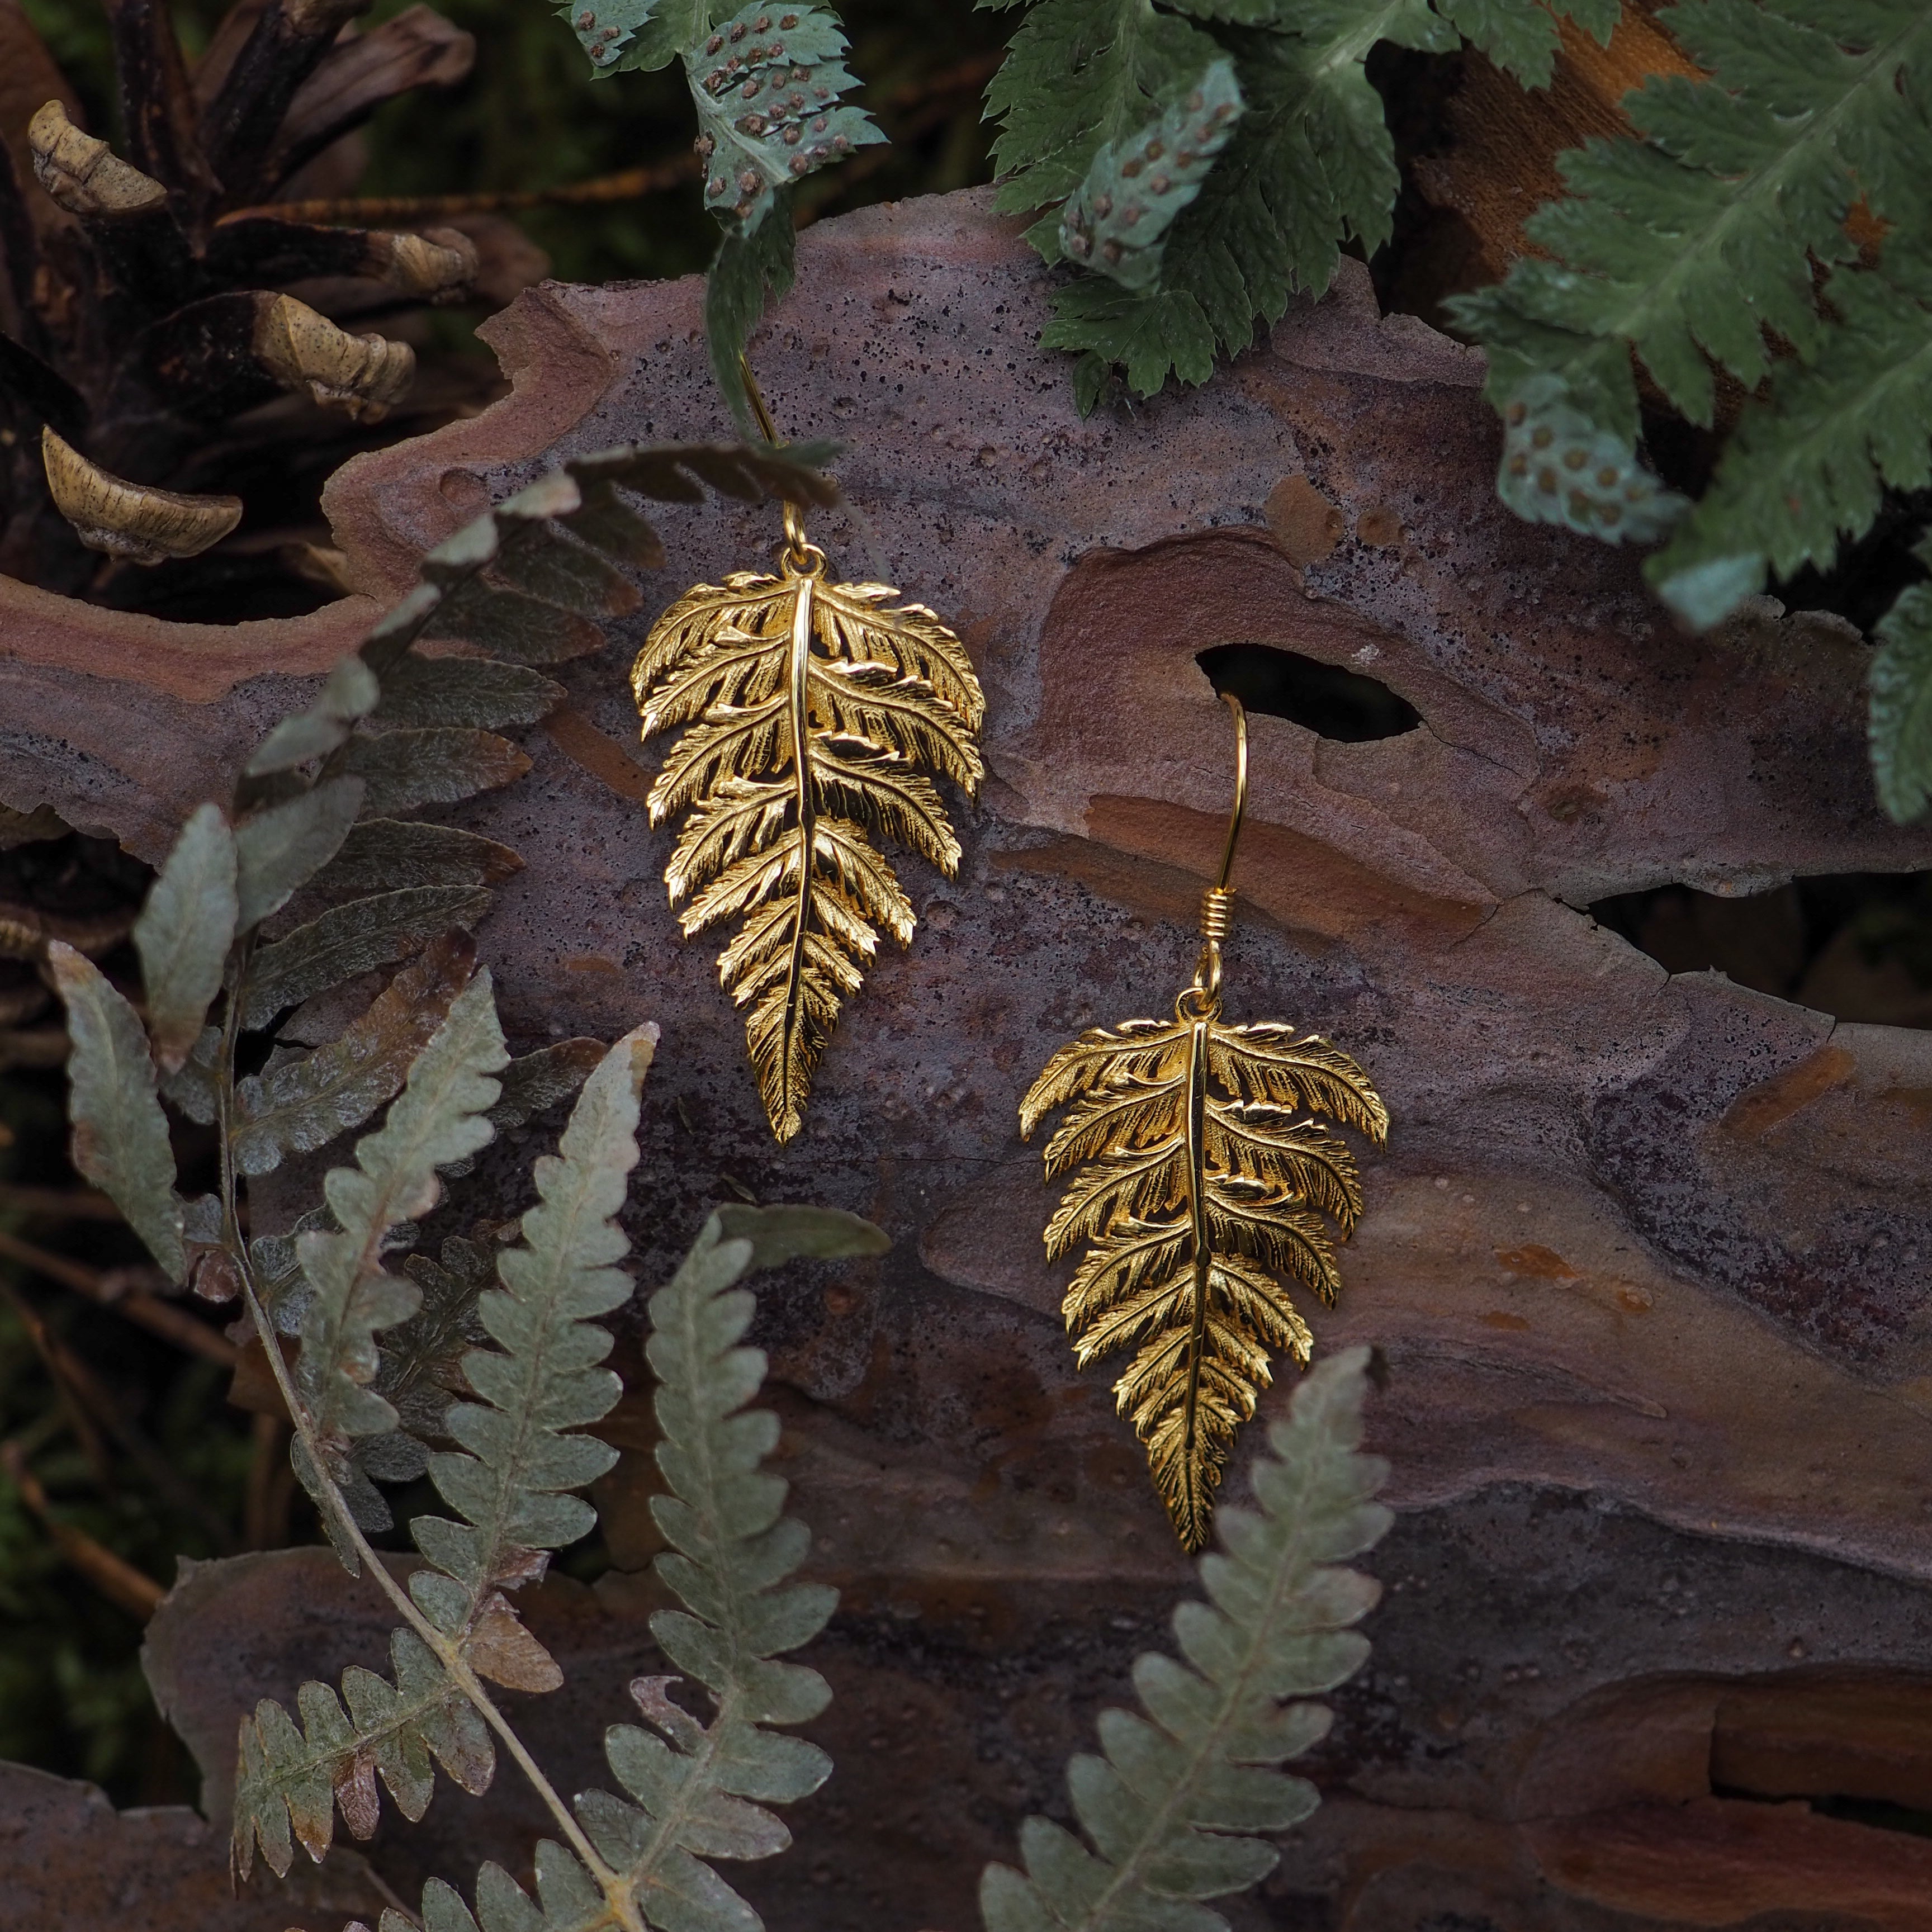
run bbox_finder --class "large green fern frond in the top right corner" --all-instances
[1449,0,1932,626]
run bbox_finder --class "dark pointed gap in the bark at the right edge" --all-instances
[1590,872,1932,1026]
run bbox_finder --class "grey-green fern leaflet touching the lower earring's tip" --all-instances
[979,1348,1393,1932]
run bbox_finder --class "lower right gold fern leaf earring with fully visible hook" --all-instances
[1020,694,1389,1550]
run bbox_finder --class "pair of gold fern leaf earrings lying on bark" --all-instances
[632,369,1389,1550]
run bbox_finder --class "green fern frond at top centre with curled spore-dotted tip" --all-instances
[987,0,1619,400]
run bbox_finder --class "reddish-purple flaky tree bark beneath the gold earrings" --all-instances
[0,193,1932,1932]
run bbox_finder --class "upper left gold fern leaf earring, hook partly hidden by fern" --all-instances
[630,367,986,1142]
